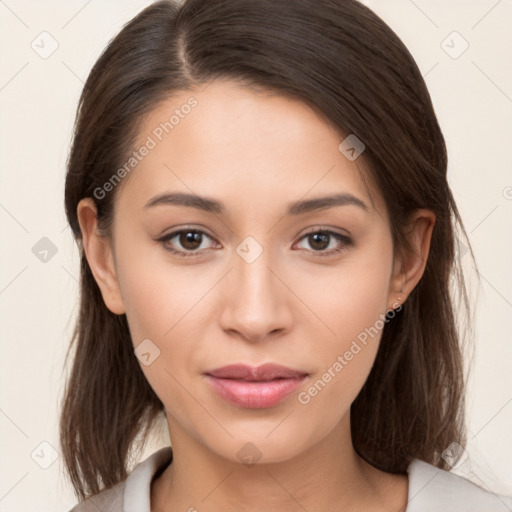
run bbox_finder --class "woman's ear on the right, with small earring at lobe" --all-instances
[388,209,436,309]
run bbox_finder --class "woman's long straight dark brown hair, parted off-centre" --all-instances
[60,0,474,499]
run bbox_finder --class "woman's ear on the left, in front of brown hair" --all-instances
[77,197,125,315]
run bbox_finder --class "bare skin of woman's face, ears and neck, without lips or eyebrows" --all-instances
[78,80,435,512]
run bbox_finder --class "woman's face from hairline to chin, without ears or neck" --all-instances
[87,81,420,462]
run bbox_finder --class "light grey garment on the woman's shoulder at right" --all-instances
[406,459,512,512]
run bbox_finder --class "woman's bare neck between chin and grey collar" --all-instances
[151,415,408,512]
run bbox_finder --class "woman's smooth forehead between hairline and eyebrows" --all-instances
[118,80,383,219]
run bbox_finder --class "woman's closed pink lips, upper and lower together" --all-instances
[205,363,308,409]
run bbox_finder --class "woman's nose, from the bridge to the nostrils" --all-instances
[220,244,293,342]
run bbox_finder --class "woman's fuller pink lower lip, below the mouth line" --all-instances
[207,375,306,409]
